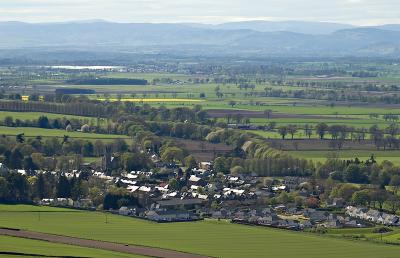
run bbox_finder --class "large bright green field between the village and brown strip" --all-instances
[0,205,400,258]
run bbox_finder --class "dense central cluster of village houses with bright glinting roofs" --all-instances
[87,163,364,230]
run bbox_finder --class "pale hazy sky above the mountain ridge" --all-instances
[0,0,400,25]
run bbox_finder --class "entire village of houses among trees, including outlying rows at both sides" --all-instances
[7,153,400,230]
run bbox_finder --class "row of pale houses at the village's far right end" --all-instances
[346,206,400,226]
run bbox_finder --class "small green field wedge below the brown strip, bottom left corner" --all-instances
[0,236,141,258]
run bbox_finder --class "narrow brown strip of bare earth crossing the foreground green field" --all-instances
[0,228,206,258]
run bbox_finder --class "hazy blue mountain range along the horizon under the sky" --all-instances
[0,21,400,57]
